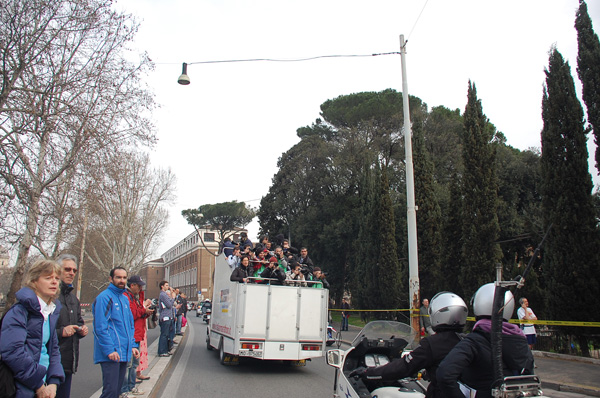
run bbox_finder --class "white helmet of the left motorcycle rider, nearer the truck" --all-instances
[429,292,469,330]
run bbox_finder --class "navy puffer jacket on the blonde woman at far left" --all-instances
[0,287,65,398]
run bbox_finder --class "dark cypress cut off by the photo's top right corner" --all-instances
[575,0,600,172]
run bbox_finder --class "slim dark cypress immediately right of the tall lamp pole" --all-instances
[412,119,442,297]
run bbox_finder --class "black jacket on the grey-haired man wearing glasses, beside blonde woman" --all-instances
[56,282,85,373]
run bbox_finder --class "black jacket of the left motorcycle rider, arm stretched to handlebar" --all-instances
[366,331,464,398]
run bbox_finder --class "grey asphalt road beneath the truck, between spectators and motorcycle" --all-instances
[156,317,334,398]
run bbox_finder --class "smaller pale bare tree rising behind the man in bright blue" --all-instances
[79,152,175,280]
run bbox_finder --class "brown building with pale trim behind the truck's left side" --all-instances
[162,228,247,301]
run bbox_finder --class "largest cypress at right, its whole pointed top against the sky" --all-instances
[541,48,600,346]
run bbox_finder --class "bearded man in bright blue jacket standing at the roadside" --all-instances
[92,267,140,398]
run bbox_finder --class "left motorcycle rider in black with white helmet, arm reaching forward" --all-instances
[349,292,468,398]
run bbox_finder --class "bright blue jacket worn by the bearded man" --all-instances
[92,283,135,363]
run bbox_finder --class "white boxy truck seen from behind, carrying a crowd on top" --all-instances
[206,254,329,366]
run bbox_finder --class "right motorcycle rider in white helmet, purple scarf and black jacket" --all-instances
[437,283,533,398]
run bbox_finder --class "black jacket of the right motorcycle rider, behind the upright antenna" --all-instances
[437,323,533,398]
